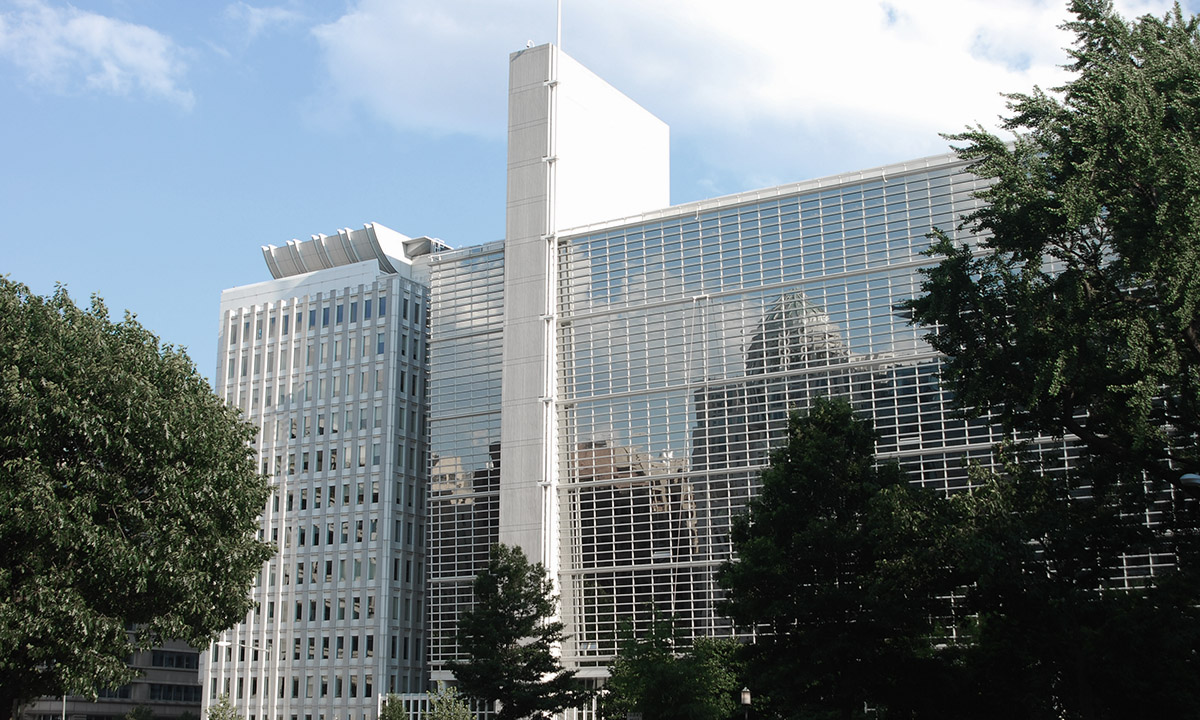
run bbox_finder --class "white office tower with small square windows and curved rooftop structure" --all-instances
[202,224,442,720]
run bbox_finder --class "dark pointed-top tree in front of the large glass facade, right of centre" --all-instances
[718,398,956,718]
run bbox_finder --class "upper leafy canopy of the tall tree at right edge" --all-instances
[907,0,1200,489]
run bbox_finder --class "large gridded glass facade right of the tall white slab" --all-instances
[557,151,1065,672]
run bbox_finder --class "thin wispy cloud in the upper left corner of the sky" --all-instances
[0,0,194,109]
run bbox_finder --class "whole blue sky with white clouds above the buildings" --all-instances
[0,0,1195,378]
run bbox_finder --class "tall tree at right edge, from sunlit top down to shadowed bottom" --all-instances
[906,0,1200,718]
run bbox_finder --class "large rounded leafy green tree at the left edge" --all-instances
[0,277,270,718]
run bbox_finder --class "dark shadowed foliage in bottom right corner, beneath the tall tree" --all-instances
[954,454,1200,720]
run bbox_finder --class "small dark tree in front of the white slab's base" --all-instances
[446,544,592,720]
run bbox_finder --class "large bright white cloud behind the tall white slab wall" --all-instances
[314,0,1190,186]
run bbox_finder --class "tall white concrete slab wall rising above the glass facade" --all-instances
[499,46,670,569]
